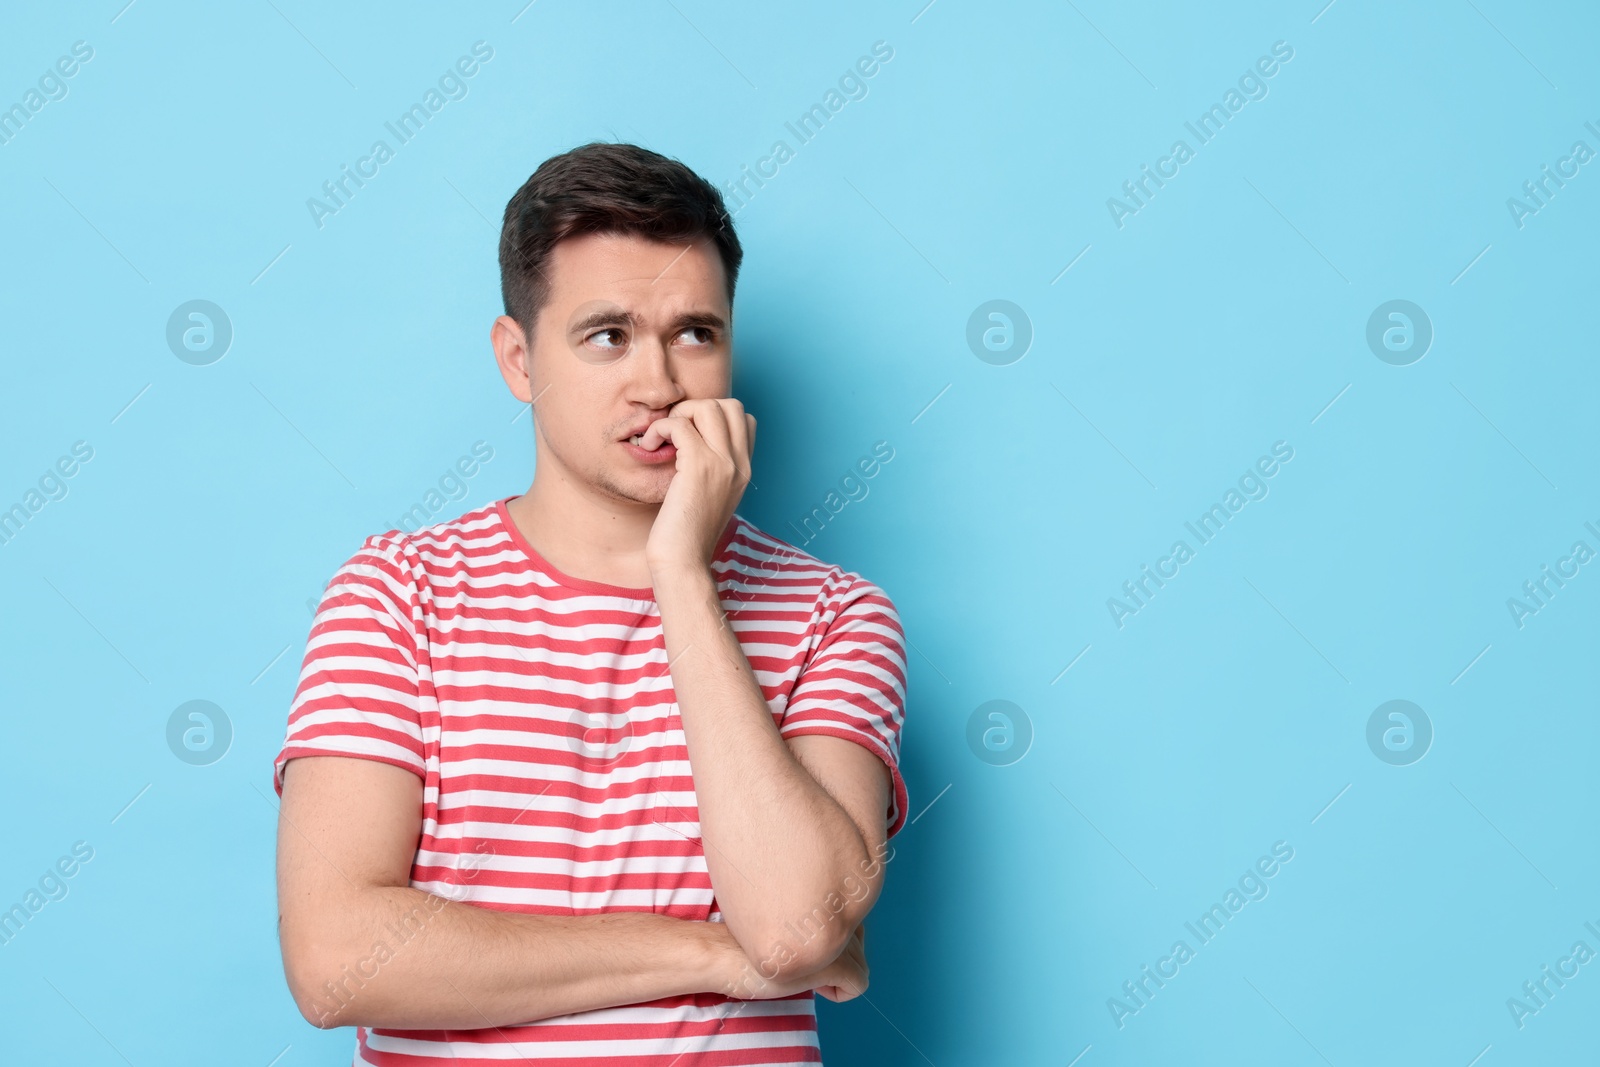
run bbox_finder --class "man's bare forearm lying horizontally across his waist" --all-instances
[285,886,744,1030]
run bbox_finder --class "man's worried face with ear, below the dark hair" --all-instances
[494,234,733,504]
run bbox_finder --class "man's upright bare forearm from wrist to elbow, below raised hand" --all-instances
[656,568,872,969]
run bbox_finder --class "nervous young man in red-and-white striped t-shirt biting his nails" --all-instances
[274,144,907,1067]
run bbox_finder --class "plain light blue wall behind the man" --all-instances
[0,0,1600,1067]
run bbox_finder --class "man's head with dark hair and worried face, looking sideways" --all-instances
[490,144,742,504]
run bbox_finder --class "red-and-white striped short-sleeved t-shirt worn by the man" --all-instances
[274,499,909,1067]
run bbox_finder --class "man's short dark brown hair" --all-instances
[499,141,744,333]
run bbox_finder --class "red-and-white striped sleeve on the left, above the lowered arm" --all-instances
[272,536,427,795]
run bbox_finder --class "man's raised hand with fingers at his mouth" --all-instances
[640,397,755,574]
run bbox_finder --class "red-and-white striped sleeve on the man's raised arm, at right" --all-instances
[778,576,910,837]
